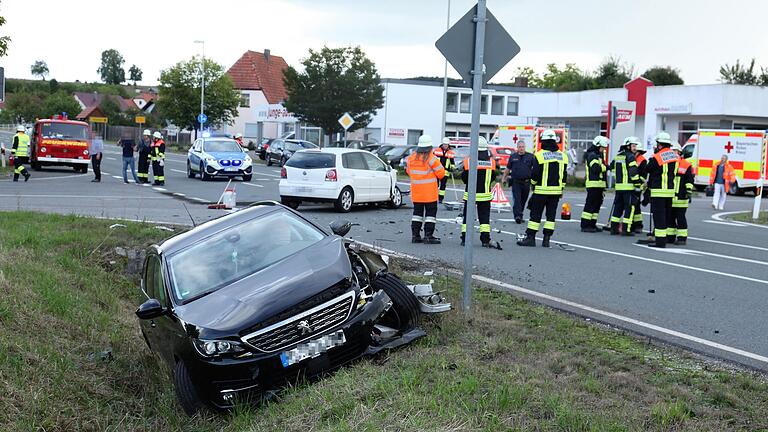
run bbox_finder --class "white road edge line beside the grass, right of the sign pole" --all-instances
[464,272,768,363]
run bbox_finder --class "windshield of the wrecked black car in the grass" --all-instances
[168,211,325,304]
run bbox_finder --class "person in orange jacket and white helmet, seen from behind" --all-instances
[405,135,445,244]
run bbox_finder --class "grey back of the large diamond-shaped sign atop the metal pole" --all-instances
[435,6,520,84]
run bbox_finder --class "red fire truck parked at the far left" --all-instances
[30,115,91,173]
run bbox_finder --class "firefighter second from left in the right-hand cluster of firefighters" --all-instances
[608,137,640,236]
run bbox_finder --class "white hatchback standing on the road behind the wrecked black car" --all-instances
[279,148,403,212]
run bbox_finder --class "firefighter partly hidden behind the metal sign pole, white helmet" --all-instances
[461,136,496,248]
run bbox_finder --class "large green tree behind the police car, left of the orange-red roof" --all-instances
[157,57,240,129]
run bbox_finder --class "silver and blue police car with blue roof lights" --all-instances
[187,137,253,181]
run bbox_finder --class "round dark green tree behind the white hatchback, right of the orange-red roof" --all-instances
[283,47,384,140]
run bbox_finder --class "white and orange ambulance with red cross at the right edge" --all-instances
[683,129,768,195]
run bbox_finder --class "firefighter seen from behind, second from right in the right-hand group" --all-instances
[648,132,679,248]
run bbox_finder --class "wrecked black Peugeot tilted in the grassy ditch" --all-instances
[136,202,440,415]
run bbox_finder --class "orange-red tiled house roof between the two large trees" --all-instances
[227,50,288,104]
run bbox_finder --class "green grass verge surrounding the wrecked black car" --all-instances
[0,212,768,431]
